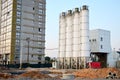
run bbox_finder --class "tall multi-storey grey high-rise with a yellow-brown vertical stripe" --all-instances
[0,0,46,64]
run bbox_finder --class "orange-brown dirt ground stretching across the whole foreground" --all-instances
[0,68,120,80]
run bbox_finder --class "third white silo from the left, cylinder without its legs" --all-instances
[73,8,80,58]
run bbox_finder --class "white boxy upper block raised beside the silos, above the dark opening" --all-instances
[90,29,111,53]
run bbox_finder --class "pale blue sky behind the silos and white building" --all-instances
[45,0,120,57]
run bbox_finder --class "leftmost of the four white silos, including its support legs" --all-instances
[59,12,66,68]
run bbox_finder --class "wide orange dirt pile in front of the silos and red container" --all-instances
[73,68,120,79]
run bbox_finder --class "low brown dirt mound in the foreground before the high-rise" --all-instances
[16,71,51,79]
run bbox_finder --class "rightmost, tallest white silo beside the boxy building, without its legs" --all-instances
[81,5,90,57]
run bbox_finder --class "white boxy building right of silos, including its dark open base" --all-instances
[89,29,112,67]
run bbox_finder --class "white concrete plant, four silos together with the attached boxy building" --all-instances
[58,5,115,69]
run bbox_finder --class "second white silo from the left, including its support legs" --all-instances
[65,10,72,68]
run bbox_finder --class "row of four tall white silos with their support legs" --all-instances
[59,5,90,69]
